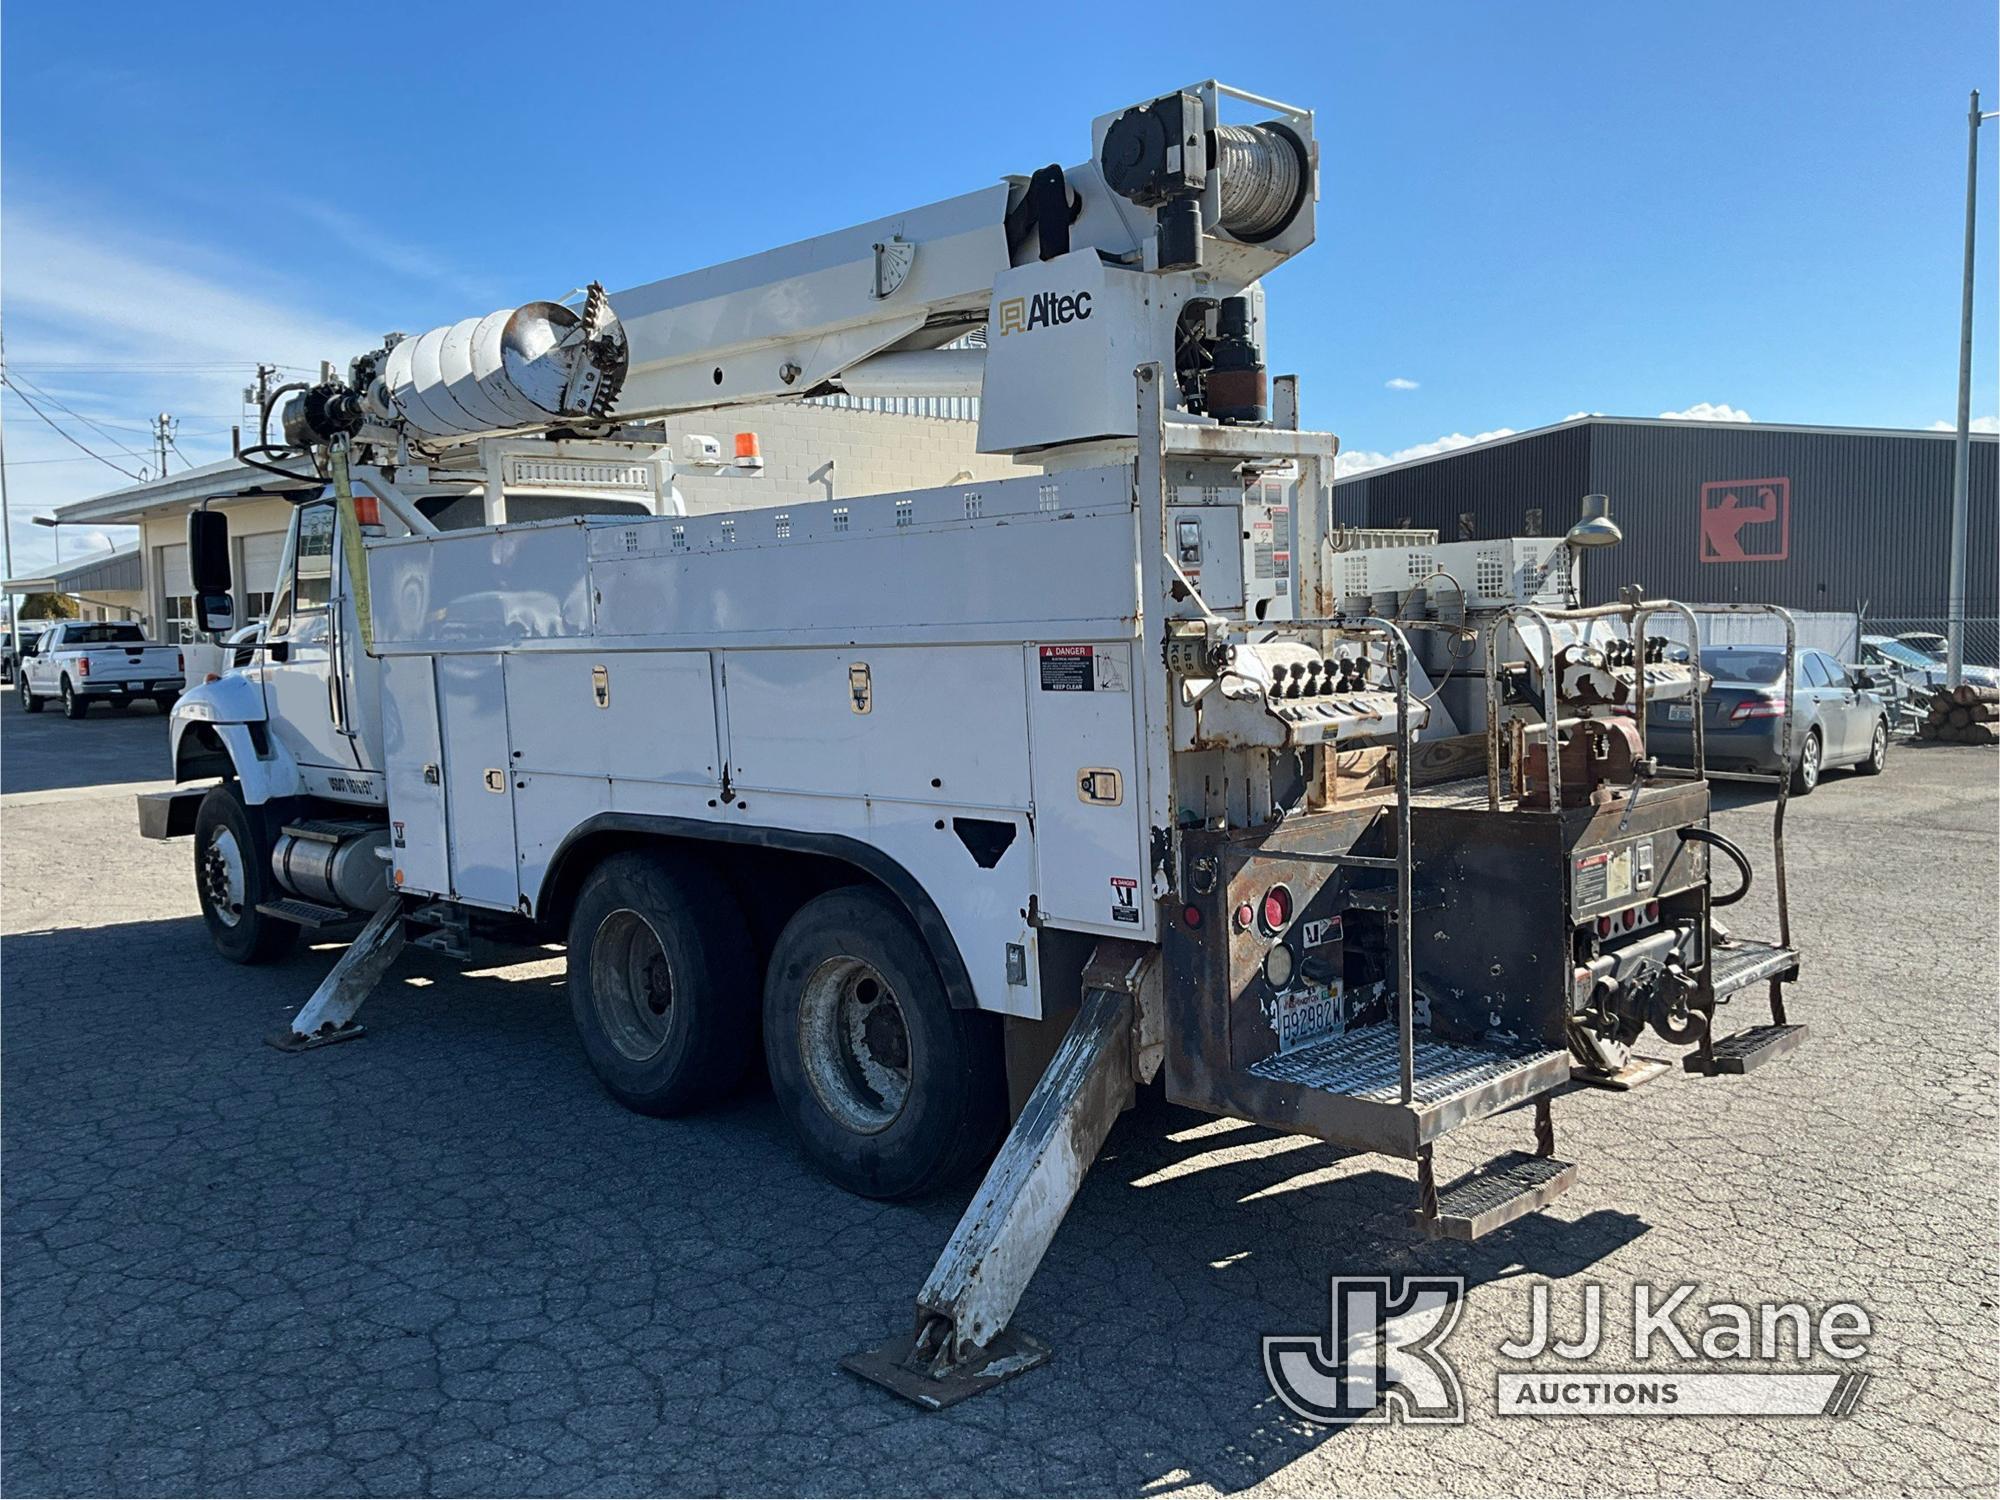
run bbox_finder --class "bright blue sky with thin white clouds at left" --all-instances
[0,0,2000,572]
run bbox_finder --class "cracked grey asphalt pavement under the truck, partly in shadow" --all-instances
[0,700,2000,1494]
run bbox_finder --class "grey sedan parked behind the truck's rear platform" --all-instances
[1646,646,1890,796]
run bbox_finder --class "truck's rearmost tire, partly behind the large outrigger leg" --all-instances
[764,886,1006,1198]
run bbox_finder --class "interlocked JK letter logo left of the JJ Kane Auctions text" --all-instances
[1264,1276,1466,1426]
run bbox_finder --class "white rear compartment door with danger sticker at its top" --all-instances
[1024,640,1154,938]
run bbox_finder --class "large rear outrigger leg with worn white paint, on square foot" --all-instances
[840,944,1150,1410]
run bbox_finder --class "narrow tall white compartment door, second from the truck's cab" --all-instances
[436,652,520,910]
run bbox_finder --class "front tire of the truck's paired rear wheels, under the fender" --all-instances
[566,850,756,1116]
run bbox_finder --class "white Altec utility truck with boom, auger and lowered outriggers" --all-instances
[140,82,1802,1406]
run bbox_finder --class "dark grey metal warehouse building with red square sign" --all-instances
[1334,416,2000,640]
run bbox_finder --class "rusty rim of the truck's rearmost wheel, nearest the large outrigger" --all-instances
[798,958,910,1136]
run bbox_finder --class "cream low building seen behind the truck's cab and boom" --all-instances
[56,398,1020,642]
